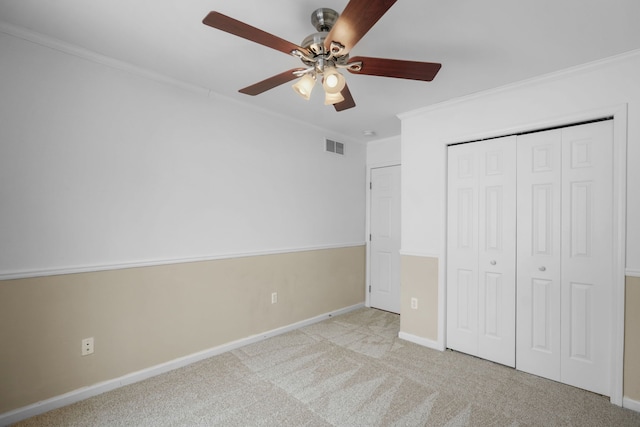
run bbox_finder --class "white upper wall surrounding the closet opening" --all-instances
[401,51,640,273]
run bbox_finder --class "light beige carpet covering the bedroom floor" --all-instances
[13,308,640,426]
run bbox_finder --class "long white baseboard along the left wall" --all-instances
[0,304,364,426]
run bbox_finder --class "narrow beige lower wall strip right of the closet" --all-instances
[624,276,640,402]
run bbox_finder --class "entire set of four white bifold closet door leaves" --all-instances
[447,120,613,395]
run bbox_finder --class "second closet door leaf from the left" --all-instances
[478,137,516,367]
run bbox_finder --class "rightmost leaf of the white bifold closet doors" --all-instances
[561,121,613,395]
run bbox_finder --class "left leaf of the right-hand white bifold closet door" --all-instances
[516,130,562,380]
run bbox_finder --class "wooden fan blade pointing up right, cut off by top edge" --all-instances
[324,0,397,54]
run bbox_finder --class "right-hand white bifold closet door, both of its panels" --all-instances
[516,120,613,395]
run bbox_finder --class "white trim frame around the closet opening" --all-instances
[438,103,628,406]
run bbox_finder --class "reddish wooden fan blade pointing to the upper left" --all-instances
[202,12,309,55]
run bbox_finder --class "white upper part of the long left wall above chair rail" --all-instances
[0,34,366,279]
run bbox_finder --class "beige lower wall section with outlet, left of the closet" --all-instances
[400,255,438,341]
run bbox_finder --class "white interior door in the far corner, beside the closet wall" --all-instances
[369,166,400,314]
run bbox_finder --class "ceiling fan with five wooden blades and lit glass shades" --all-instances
[202,0,441,111]
